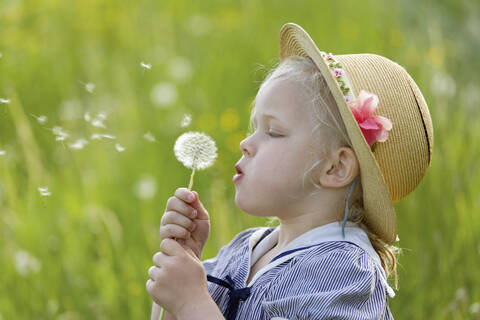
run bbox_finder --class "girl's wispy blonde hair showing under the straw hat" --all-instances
[250,56,401,289]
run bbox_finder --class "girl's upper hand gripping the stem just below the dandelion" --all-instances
[160,188,210,260]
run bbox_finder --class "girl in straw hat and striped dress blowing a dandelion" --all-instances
[147,23,433,320]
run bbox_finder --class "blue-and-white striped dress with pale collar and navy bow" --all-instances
[203,222,395,320]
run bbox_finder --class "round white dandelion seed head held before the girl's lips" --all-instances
[173,132,217,170]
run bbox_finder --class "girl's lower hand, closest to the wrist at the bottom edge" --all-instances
[146,239,211,317]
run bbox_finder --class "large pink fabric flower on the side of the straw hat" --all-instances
[348,90,392,147]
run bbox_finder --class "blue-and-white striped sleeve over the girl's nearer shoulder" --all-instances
[263,241,389,319]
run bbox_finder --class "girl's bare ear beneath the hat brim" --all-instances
[319,147,360,188]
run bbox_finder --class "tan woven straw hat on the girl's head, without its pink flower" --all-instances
[280,23,433,244]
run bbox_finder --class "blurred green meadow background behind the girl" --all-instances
[0,0,480,320]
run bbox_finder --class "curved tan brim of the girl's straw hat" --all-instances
[279,23,397,244]
